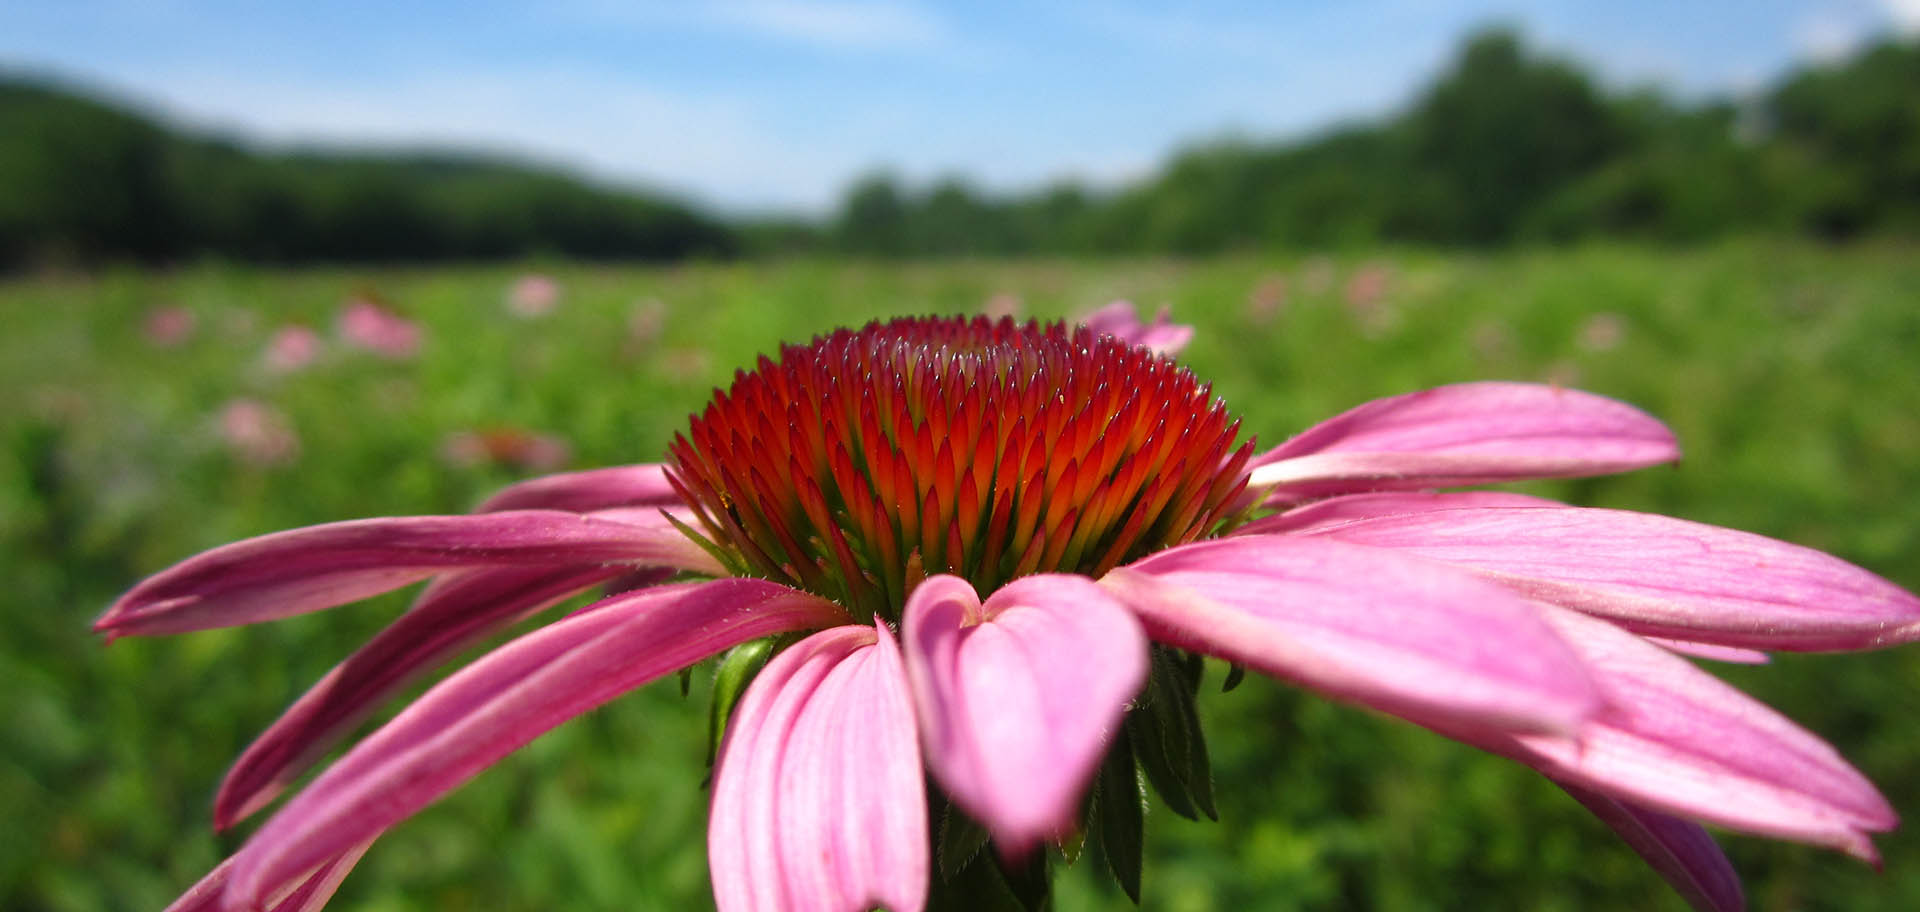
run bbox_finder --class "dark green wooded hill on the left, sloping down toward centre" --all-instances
[0,79,737,269]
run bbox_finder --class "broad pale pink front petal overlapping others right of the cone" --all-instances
[1100,536,1597,732]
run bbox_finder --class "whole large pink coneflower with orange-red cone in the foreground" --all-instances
[108,311,1920,910]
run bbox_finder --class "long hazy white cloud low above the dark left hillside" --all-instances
[97,69,845,211]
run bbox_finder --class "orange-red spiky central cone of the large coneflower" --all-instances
[666,317,1254,620]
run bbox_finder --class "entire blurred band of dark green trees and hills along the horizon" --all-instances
[0,31,1920,267]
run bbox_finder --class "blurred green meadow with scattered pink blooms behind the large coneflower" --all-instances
[0,240,1920,912]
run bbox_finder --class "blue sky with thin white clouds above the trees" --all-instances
[0,0,1920,213]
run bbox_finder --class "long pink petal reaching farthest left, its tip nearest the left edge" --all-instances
[94,511,724,636]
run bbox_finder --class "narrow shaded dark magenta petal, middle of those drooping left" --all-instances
[213,564,656,829]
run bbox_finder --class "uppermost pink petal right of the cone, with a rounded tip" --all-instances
[1250,382,1680,503]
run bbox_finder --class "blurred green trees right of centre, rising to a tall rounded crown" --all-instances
[829,31,1920,255]
